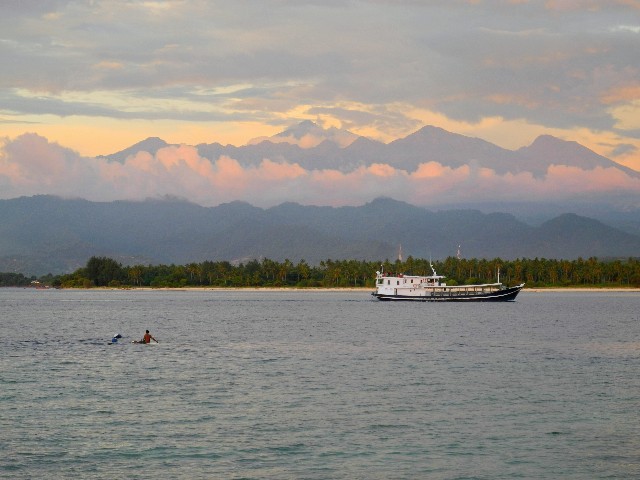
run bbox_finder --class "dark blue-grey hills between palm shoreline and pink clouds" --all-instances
[0,196,640,275]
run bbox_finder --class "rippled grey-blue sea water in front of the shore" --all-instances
[0,289,640,479]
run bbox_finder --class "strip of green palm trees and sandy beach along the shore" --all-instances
[0,257,640,288]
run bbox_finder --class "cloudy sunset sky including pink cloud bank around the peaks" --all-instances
[0,0,640,205]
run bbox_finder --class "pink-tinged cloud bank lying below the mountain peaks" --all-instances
[0,134,640,207]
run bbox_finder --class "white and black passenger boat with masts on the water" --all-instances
[371,265,524,302]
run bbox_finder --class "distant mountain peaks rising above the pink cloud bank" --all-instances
[102,120,640,178]
